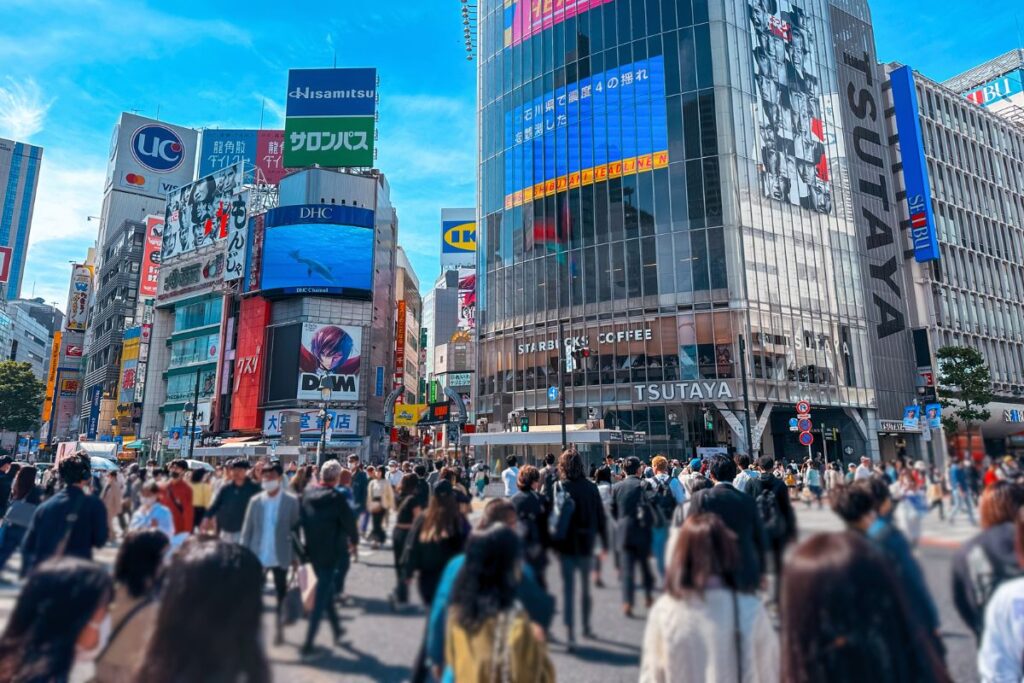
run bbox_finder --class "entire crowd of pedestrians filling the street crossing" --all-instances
[0,447,1024,683]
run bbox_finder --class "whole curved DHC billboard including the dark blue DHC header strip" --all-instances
[260,204,374,299]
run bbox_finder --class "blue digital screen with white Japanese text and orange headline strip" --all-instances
[505,56,669,208]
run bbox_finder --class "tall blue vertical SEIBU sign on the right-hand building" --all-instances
[889,67,939,263]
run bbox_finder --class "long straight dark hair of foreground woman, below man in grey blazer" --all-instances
[135,537,270,683]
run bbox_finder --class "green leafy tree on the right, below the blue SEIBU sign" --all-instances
[936,346,995,454]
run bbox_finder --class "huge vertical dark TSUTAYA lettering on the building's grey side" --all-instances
[830,5,906,340]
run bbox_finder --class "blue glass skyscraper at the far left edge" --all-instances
[0,138,43,301]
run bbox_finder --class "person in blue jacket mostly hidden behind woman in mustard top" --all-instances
[427,498,555,683]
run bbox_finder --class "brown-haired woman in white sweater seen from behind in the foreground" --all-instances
[640,513,778,683]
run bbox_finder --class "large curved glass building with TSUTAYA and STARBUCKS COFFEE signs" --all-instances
[476,0,913,460]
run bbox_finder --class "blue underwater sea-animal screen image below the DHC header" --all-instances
[262,223,374,298]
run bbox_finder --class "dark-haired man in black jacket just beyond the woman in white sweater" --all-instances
[689,456,767,593]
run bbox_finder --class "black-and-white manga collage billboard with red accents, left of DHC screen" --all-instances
[161,163,248,263]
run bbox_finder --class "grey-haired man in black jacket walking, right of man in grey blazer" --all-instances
[299,460,359,656]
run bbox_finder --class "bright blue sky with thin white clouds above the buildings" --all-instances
[0,0,1024,306]
